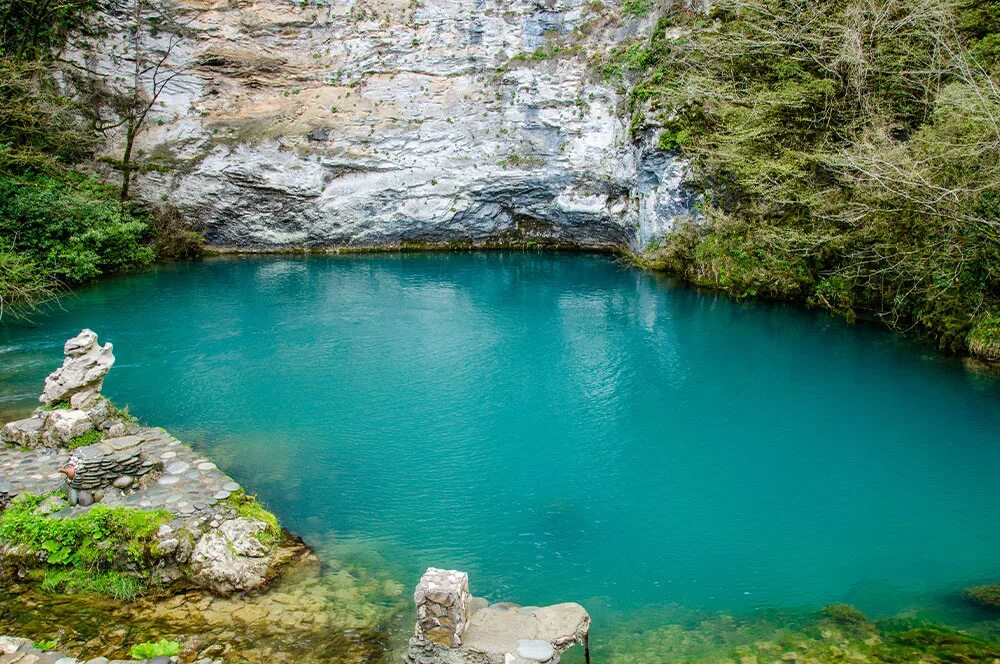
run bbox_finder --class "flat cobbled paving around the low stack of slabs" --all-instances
[0,428,240,517]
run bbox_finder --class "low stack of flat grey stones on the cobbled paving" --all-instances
[67,436,156,491]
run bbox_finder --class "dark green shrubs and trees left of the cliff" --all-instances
[0,0,201,322]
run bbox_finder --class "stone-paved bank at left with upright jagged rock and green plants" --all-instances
[0,330,305,594]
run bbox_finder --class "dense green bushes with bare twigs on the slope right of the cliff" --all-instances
[616,0,1000,357]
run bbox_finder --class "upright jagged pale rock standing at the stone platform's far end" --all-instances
[38,329,115,409]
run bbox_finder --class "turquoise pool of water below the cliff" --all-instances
[0,252,1000,628]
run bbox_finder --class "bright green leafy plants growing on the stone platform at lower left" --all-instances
[0,494,170,598]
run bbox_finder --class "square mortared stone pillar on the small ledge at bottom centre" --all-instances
[413,567,472,648]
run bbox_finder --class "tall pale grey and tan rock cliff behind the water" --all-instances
[66,0,689,248]
